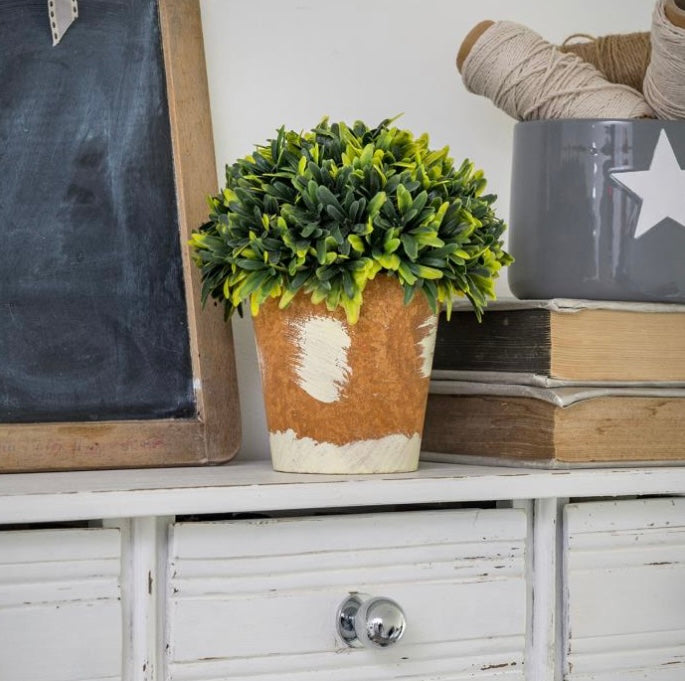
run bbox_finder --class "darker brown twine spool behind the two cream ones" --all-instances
[559,33,651,92]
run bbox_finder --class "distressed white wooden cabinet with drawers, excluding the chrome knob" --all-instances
[0,461,685,681]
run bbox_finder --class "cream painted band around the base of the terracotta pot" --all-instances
[269,429,421,473]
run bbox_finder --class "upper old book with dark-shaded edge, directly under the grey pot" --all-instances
[432,299,685,386]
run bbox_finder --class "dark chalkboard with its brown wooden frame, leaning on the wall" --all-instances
[0,0,239,471]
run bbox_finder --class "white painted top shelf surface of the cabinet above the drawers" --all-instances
[0,460,685,525]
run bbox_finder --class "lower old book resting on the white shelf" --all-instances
[422,381,685,467]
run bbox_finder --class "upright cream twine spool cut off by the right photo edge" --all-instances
[643,0,685,120]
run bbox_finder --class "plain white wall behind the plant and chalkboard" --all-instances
[201,0,653,458]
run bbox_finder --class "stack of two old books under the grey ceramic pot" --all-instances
[423,299,685,467]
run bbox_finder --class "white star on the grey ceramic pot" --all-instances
[611,130,685,239]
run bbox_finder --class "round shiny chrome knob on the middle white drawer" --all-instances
[337,593,407,648]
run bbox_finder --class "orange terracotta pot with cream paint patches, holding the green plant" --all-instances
[254,274,437,473]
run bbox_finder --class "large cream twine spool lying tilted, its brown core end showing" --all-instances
[462,21,653,120]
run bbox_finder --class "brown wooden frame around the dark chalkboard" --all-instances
[0,0,240,472]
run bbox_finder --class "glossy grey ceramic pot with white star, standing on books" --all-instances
[509,120,685,303]
